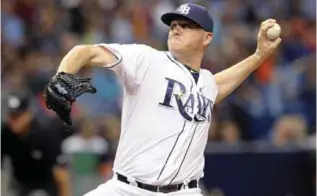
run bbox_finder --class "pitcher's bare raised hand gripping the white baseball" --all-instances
[255,19,282,59]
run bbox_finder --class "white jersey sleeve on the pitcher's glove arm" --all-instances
[97,44,154,91]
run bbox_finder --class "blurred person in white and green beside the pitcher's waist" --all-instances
[62,119,112,195]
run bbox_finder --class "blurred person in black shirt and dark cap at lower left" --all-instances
[1,92,71,196]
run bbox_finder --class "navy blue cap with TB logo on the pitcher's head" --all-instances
[161,3,214,32]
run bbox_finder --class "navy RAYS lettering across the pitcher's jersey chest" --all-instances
[159,78,213,122]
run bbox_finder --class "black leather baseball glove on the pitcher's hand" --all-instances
[44,72,97,125]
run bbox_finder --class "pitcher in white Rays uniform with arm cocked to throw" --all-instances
[45,3,281,196]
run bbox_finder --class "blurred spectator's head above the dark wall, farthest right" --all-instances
[272,115,307,147]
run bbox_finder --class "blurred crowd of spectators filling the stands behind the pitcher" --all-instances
[1,0,316,151]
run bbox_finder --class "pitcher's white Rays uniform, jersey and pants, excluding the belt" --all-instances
[87,44,218,196]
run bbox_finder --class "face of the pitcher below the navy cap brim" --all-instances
[167,20,212,53]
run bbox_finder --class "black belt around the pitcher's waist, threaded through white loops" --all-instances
[117,173,198,193]
